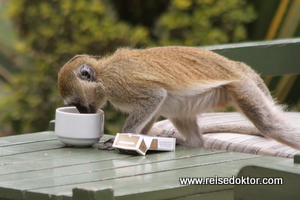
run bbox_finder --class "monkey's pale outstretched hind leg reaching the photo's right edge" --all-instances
[226,79,300,149]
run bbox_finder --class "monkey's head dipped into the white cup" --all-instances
[58,55,105,113]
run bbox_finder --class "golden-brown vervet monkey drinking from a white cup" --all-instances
[58,46,300,149]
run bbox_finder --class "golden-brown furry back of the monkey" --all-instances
[101,46,246,94]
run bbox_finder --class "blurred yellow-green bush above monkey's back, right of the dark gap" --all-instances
[155,0,255,46]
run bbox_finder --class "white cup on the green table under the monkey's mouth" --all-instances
[54,107,104,147]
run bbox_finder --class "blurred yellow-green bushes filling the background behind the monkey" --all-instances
[0,0,255,134]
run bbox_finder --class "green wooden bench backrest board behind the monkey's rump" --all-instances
[201,38,300,76]
